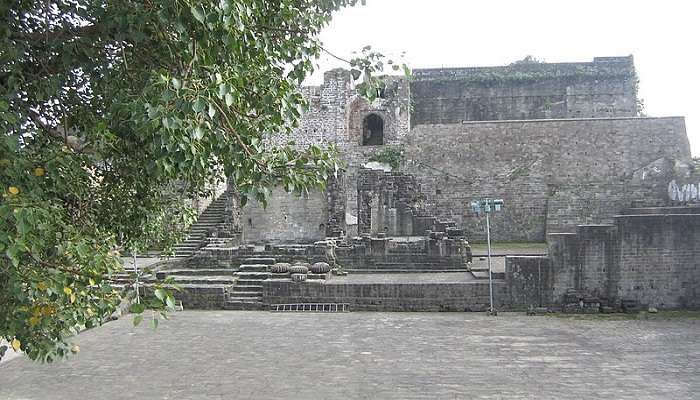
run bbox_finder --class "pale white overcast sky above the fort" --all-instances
[309,0,700,156]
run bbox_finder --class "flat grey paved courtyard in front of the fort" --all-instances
[0,312,700,400]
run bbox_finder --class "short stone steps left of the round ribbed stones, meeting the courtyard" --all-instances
[224,258,275,310]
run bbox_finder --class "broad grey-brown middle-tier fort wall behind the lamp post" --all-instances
[402,117,690,241]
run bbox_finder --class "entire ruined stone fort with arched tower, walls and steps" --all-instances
[165,56,700,312]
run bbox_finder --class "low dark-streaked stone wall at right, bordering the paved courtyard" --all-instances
[548,208,700,308]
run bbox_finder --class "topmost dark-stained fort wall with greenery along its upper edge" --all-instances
[411,56,637,126]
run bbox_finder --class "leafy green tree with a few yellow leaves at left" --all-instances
[0,0,400,361]
